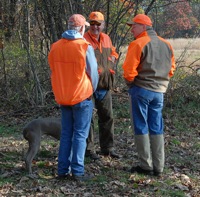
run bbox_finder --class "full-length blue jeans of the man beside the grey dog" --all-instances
[58,99,93,176]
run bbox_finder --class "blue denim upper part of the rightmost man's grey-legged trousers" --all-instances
[128,86,163,135]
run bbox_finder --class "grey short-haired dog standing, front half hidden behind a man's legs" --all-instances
[23,118,61,174]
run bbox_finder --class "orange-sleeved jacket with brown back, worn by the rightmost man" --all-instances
[122,27,175,92]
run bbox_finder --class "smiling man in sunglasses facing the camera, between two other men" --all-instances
[84,11,120,159]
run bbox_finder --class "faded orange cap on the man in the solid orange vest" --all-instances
[68,14,90,27]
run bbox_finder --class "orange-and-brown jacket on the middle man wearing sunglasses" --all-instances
[84,31,119,90]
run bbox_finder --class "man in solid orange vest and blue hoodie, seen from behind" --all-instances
[48,14,98,181]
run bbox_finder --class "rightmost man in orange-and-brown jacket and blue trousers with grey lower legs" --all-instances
[123,14,175,176]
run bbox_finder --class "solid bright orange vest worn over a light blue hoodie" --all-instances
[48,38,93,105]
